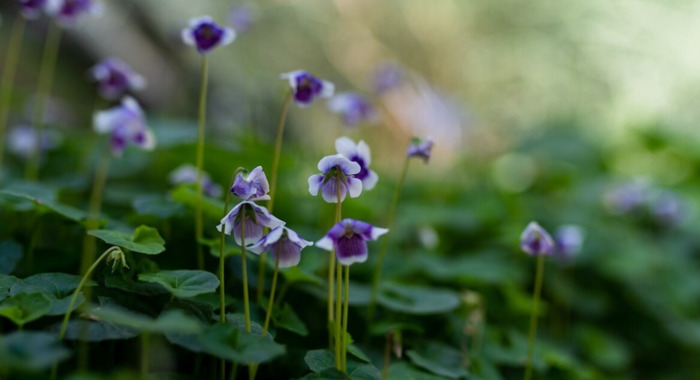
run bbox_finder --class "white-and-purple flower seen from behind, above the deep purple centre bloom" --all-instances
[309,154,362,203]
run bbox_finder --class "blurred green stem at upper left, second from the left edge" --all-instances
[25,22,62,180]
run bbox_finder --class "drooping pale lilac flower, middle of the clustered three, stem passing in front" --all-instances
[216,201,284,245]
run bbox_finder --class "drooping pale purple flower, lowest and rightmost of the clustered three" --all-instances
[249,226,313,268]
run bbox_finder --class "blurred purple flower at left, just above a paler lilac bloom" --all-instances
[90,58,146,100]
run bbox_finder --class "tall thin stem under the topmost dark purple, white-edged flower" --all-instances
[194,54,209,270]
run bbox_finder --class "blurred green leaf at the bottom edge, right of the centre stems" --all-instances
[406,343,468,379]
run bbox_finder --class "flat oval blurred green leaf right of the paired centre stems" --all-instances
[378,283,462,314]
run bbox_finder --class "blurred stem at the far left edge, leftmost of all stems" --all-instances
[0,17,26,181]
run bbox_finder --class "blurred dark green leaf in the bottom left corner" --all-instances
[0,331,70,372]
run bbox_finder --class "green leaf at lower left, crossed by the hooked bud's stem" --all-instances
[10,273,97,315]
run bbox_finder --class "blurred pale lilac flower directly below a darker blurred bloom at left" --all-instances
[93,96,156,157]
